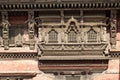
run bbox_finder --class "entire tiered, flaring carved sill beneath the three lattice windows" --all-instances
[38,43,107,60]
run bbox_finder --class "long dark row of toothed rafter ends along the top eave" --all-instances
[0,0,120,9]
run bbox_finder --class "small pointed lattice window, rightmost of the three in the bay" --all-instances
[87,29,97,42]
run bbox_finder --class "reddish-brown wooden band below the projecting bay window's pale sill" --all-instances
[39,65,108,71]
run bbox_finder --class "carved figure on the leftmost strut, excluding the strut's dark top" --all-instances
[2,20,10,50]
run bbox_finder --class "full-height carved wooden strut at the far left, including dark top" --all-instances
[2,12,10,50]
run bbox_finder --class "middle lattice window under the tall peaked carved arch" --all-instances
[68,29,77,42]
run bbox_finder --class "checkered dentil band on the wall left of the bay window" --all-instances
[0,53,37,59]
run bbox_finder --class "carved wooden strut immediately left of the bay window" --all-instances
[27,11,35,50]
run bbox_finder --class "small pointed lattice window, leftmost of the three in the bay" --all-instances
[48,29,58,43]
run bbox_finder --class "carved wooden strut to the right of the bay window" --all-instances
[110,10,117,48]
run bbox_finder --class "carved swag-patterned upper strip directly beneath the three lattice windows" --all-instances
[38,43,107,51]
